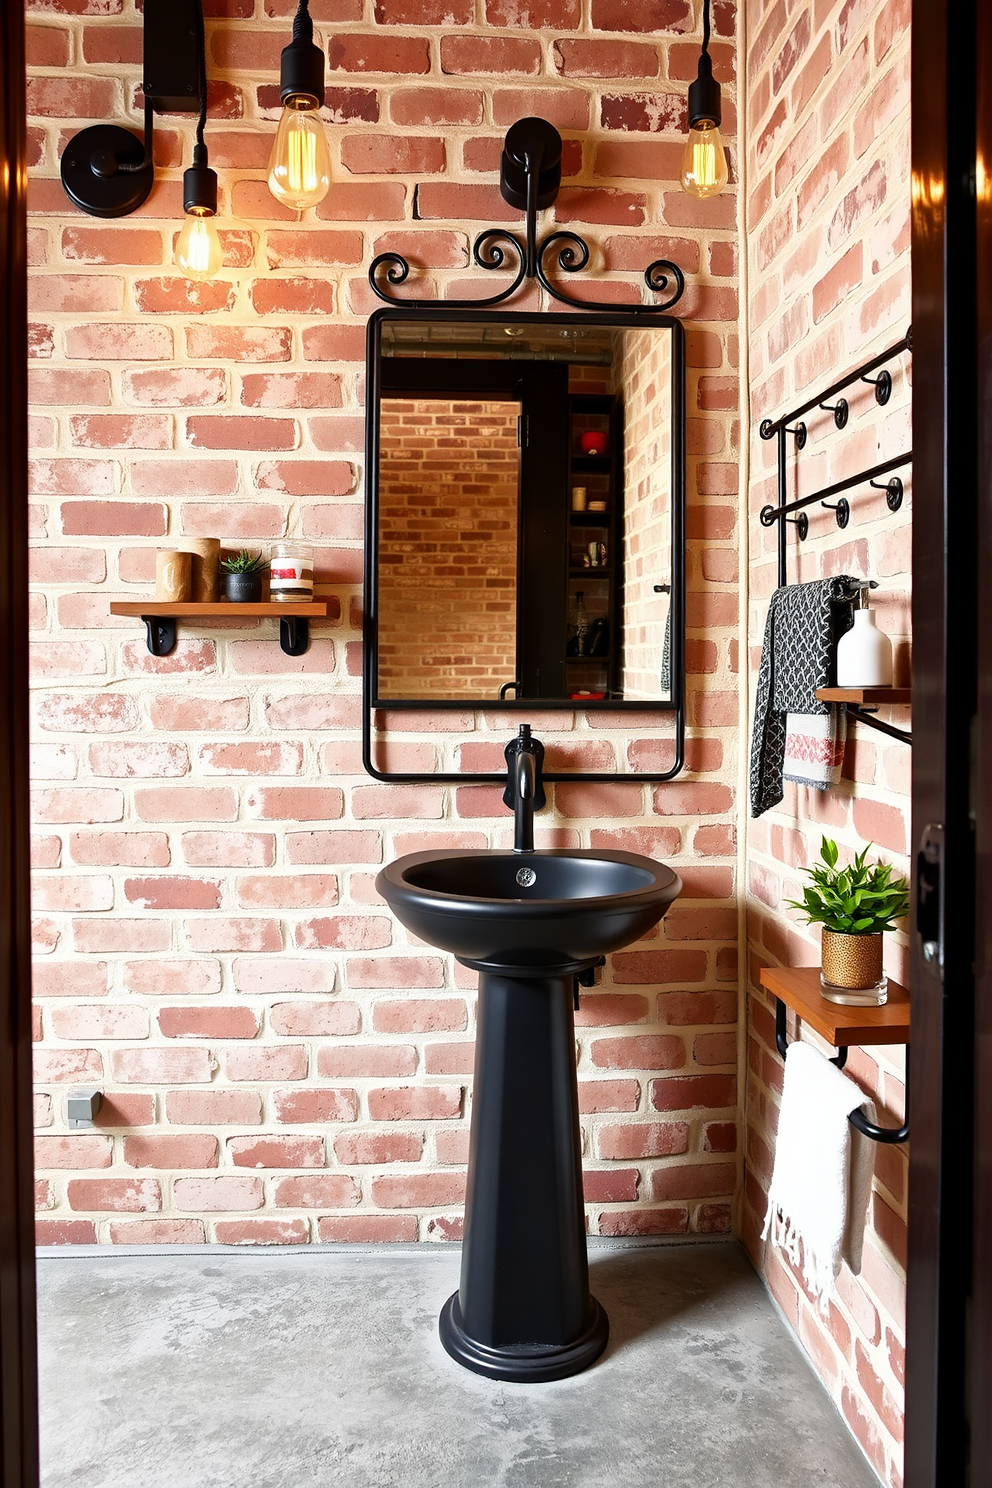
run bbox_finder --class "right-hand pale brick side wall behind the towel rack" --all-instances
[744,0,912,1484]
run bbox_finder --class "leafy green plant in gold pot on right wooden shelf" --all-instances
[785,838,909,1006]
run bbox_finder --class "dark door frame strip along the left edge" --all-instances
[0,0,39,1488]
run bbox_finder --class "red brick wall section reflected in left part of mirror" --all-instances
[379,397,519,698]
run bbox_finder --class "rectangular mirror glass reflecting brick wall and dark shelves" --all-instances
[372,314,683,705]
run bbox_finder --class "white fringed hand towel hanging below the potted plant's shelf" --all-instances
[761,1043,875,1312]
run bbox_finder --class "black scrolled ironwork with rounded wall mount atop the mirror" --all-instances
[369,119,686,315]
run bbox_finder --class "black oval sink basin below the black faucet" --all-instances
[376,848,683,970]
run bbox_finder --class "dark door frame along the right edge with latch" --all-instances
[906,0,992,1488]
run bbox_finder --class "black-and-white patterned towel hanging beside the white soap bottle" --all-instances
[751,574,857,817]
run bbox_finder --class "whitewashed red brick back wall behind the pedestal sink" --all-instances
[28,0,739,1242]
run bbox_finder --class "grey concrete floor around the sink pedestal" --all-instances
[39,1241,877,1488]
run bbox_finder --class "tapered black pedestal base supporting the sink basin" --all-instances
[440,960,610,1382]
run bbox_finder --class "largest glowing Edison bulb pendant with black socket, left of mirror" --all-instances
[269,0,330,211]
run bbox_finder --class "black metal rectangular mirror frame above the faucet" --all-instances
[361,301,686,786]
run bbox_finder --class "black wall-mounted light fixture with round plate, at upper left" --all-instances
[61,0,217,217]
